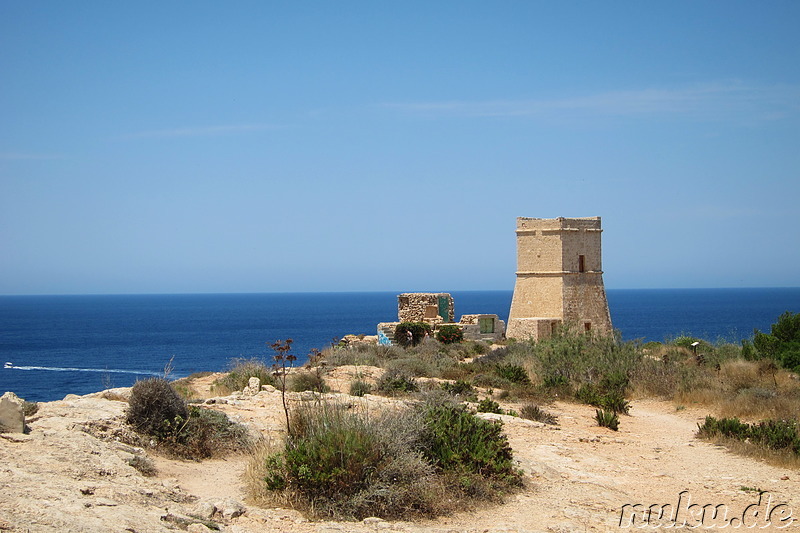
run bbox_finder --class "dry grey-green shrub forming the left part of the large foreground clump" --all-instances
[260,403,443,520]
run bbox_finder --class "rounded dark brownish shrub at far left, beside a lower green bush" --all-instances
[125,378,189,439]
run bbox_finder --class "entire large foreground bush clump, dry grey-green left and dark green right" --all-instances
[249,402,521,520]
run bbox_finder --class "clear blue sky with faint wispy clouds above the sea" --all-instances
[0,1,800,294]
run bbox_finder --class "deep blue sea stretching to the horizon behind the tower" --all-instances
[0,288,800,401]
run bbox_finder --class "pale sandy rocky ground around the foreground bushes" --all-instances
[0,367,800,533]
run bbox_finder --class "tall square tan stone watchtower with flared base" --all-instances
[506,217,612,339]
